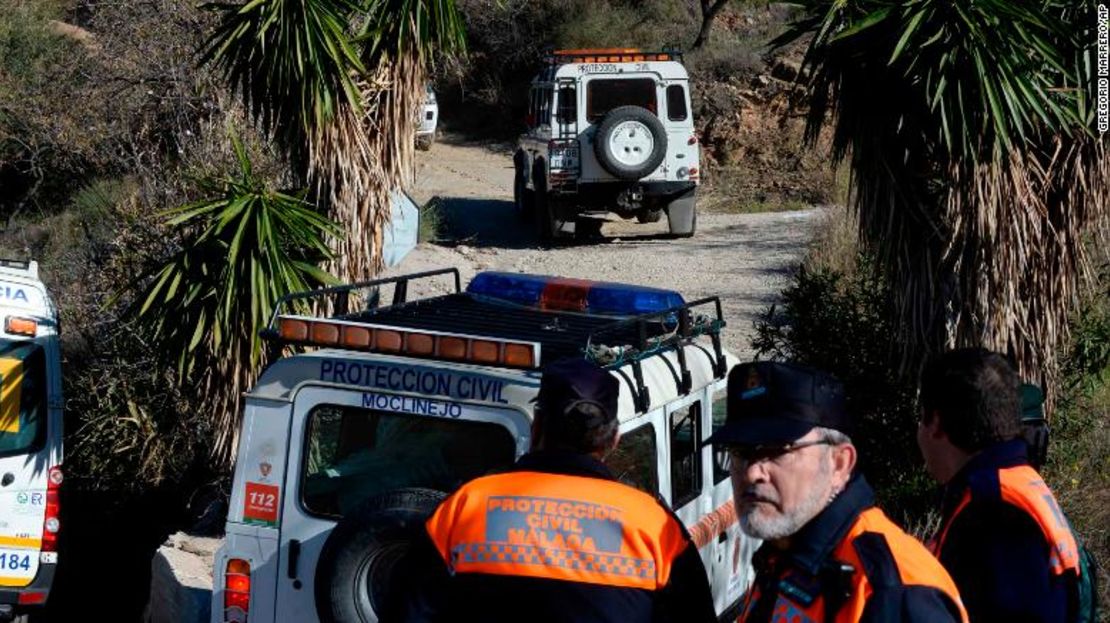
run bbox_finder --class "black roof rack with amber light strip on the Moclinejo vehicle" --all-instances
[262,269,727,411]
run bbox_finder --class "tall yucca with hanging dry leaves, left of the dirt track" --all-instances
[202,0,464,281]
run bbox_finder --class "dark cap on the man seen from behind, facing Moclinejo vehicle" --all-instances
[533,359,620,418]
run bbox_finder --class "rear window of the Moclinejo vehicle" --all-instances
[301,405,515,518]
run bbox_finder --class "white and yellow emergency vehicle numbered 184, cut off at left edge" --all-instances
[0,259,62,621]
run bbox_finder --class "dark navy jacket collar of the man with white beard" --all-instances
[757,474,875,575]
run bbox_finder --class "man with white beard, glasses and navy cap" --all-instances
[708,362,967,623]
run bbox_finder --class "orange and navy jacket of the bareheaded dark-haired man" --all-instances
[931,439,1079,623]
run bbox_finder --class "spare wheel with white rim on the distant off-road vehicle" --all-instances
[594,105,667,180]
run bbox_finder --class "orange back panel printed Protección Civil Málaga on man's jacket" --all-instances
[426,471,689,591]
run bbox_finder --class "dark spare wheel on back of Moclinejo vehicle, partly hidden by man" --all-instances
[315,489,446,623]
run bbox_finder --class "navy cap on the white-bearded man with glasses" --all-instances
[706,361,851,445]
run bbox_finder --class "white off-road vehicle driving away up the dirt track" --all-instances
[513,49,699,242]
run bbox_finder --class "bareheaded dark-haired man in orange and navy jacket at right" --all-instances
[917,349,1080,623]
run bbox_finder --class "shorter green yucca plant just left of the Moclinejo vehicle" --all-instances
[137,135,339,464]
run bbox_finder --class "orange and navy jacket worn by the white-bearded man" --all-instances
[738,475,967,623]
